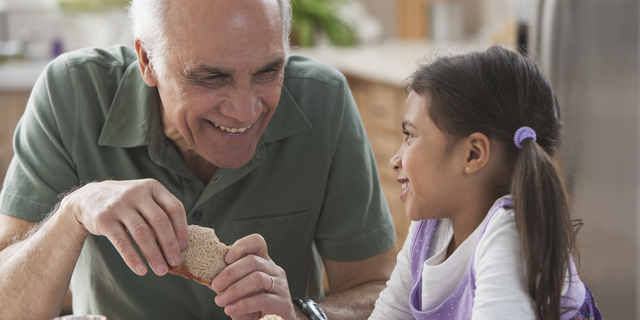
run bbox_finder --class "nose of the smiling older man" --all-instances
[220,83,262,124]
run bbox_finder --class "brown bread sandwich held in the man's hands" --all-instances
[169,225,229,286]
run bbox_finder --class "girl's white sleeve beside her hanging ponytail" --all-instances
[472,209,535,320]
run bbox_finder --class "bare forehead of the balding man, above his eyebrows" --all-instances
[161,0,286,69]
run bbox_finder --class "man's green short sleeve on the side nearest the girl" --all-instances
[315,73,396,261]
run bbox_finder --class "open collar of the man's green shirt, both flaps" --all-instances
[98,60,312,148]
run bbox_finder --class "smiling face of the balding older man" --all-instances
[152,0,285,168]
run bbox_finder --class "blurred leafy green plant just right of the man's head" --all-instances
[291,0,356,47]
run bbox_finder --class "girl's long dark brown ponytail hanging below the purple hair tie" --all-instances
[511,139,575,320]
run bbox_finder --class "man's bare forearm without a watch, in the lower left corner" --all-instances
[0,212,86,319]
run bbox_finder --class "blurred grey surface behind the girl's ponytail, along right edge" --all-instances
[547,0,640,320]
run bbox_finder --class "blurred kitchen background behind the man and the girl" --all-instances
[0,0,640,320]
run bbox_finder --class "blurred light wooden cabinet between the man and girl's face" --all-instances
[345,74,411,251]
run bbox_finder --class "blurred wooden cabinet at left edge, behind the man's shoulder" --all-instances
[0,91,30,188]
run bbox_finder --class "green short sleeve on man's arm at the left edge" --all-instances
[0,55,78,222]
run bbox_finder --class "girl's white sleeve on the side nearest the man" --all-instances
[369,222,416,320]
